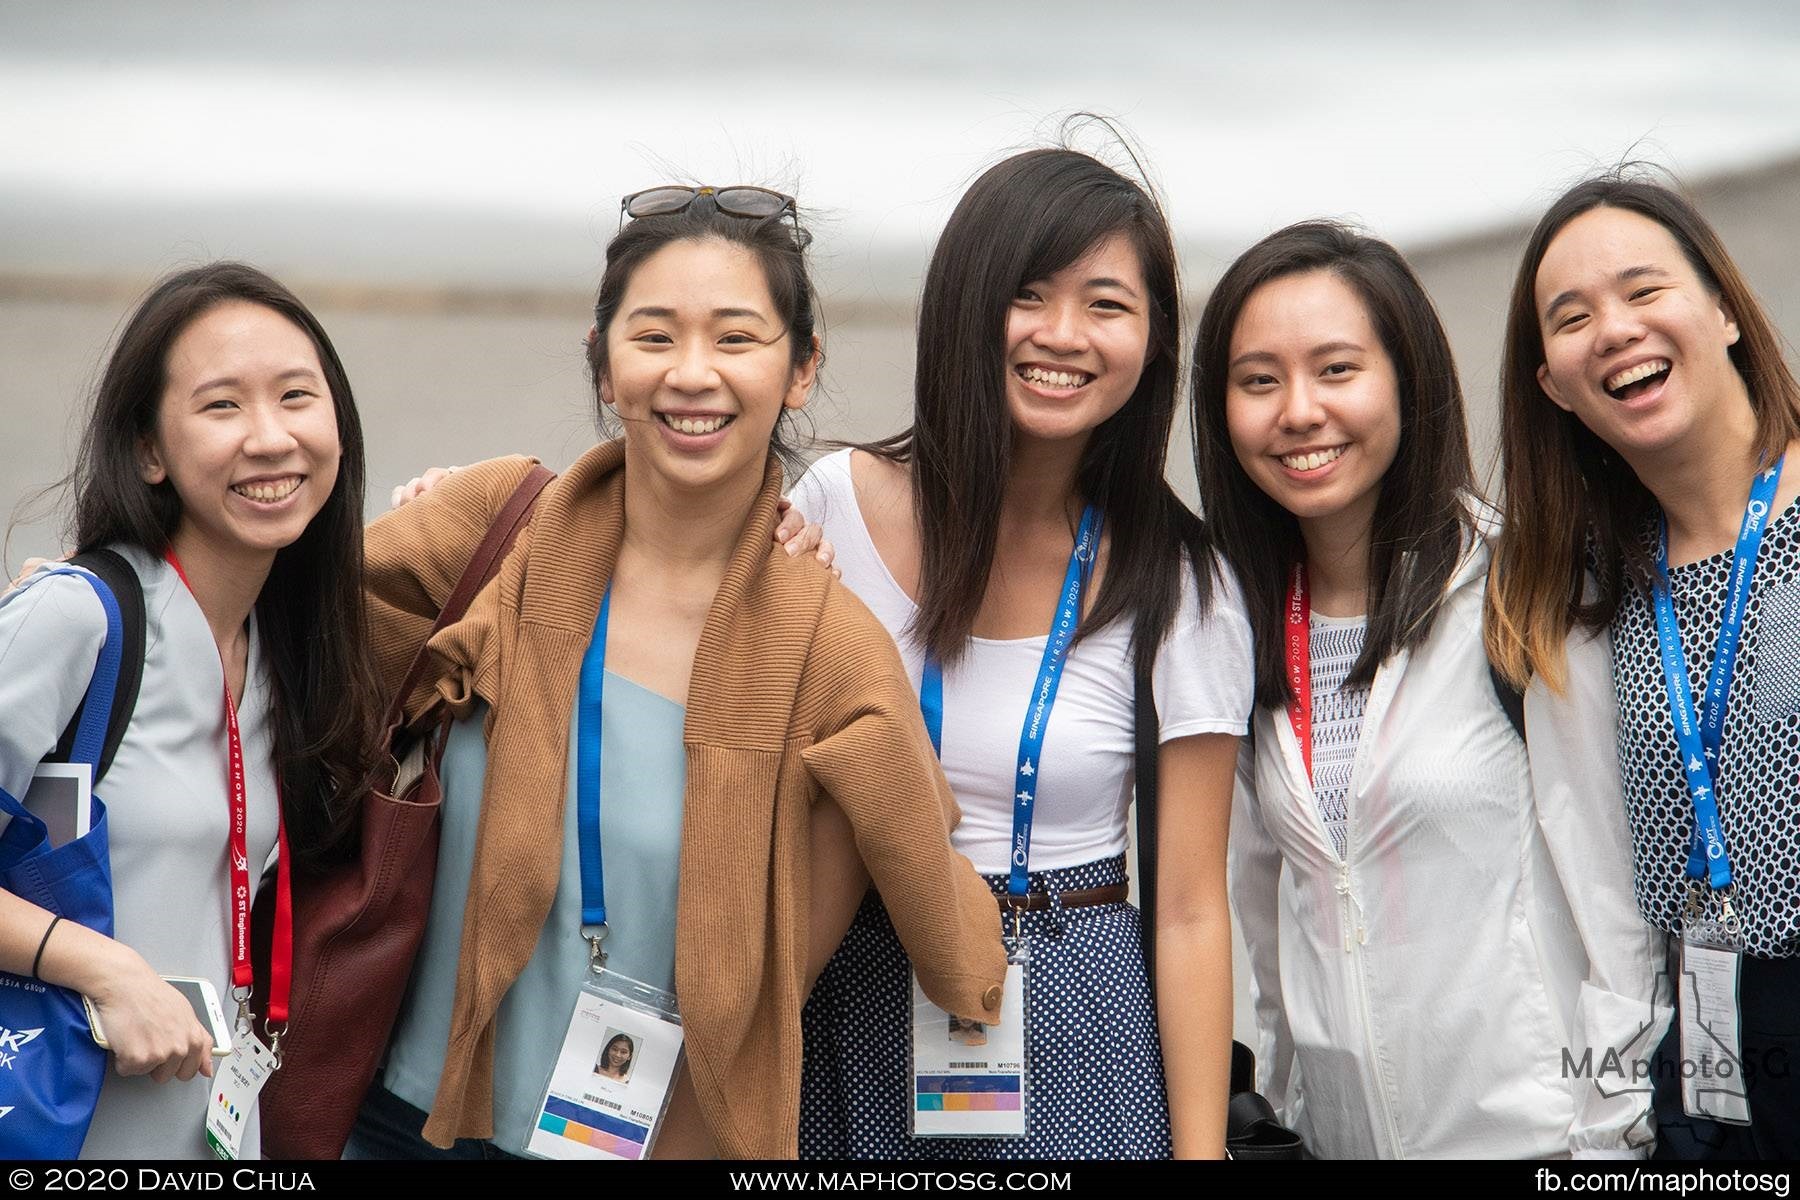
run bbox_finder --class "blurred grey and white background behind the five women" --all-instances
[0,0,1800,1029]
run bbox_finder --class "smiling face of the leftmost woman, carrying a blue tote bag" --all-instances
[139,300,340,561]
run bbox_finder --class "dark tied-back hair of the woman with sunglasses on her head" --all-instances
[587,194,824,477]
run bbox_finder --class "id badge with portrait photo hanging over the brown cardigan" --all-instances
[524,970,682,1159]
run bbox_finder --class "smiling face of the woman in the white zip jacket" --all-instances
[1226,270,1400,536]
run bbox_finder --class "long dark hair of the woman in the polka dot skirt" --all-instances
[864,149,1213,669]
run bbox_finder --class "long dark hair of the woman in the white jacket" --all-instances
[1193,221,1474,705]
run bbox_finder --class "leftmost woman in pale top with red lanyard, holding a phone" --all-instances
[0,263,374,1159]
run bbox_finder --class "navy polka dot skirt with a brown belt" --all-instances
[799,856,1170,1160]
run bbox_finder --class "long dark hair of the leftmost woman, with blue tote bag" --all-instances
[70,263,376,862]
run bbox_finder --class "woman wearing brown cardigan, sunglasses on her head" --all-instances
[351,189,1004,1157]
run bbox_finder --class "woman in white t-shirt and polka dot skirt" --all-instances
[794,149,1249,1159]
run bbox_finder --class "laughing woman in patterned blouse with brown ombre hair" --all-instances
[1489,175,1800,1159]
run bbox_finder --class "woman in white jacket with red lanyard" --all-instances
[1193,223,1667,1157]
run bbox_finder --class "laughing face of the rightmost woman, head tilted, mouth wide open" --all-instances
[1534,207,1744,459]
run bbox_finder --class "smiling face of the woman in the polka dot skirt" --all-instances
[1006,234,1150,441]
